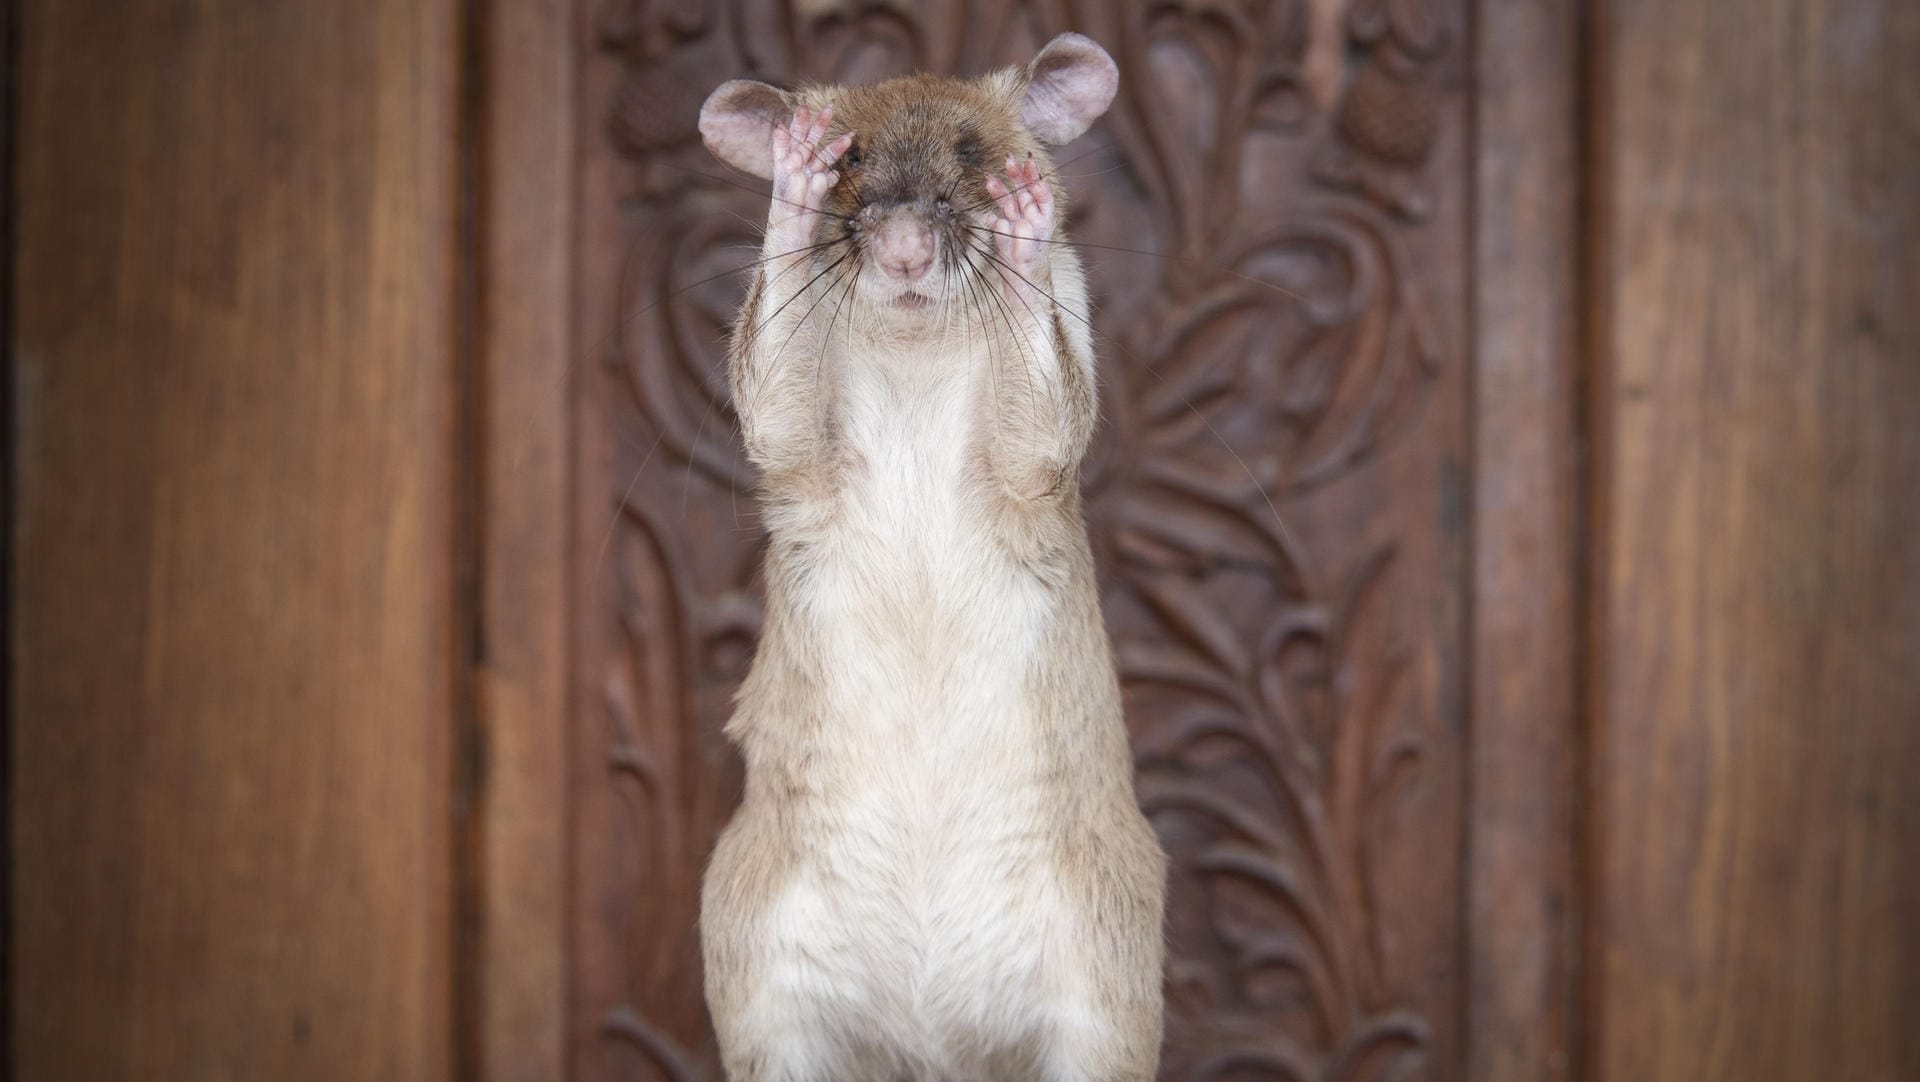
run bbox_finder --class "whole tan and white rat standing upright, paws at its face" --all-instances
[701,35,1165,1082]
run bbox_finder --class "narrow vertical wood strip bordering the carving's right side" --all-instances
[1463,2,1580,1082]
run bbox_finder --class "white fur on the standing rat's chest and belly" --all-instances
[741,358,1071,1072]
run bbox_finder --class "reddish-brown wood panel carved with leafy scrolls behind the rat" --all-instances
[572,0,1465,1080]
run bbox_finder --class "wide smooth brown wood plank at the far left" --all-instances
[8,0,455,1082]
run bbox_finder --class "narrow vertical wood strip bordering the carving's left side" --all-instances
[474,0,578,1082]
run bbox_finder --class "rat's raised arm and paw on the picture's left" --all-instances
[732,107,852,474]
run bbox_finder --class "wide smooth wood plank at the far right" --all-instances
[1590,0,1920,1082]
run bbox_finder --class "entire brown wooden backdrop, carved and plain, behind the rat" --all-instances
[0,0,1920,1082]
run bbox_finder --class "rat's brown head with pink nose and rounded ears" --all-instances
[701,35,1119,322]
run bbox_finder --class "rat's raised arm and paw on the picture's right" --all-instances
[987,159,1098,501]
